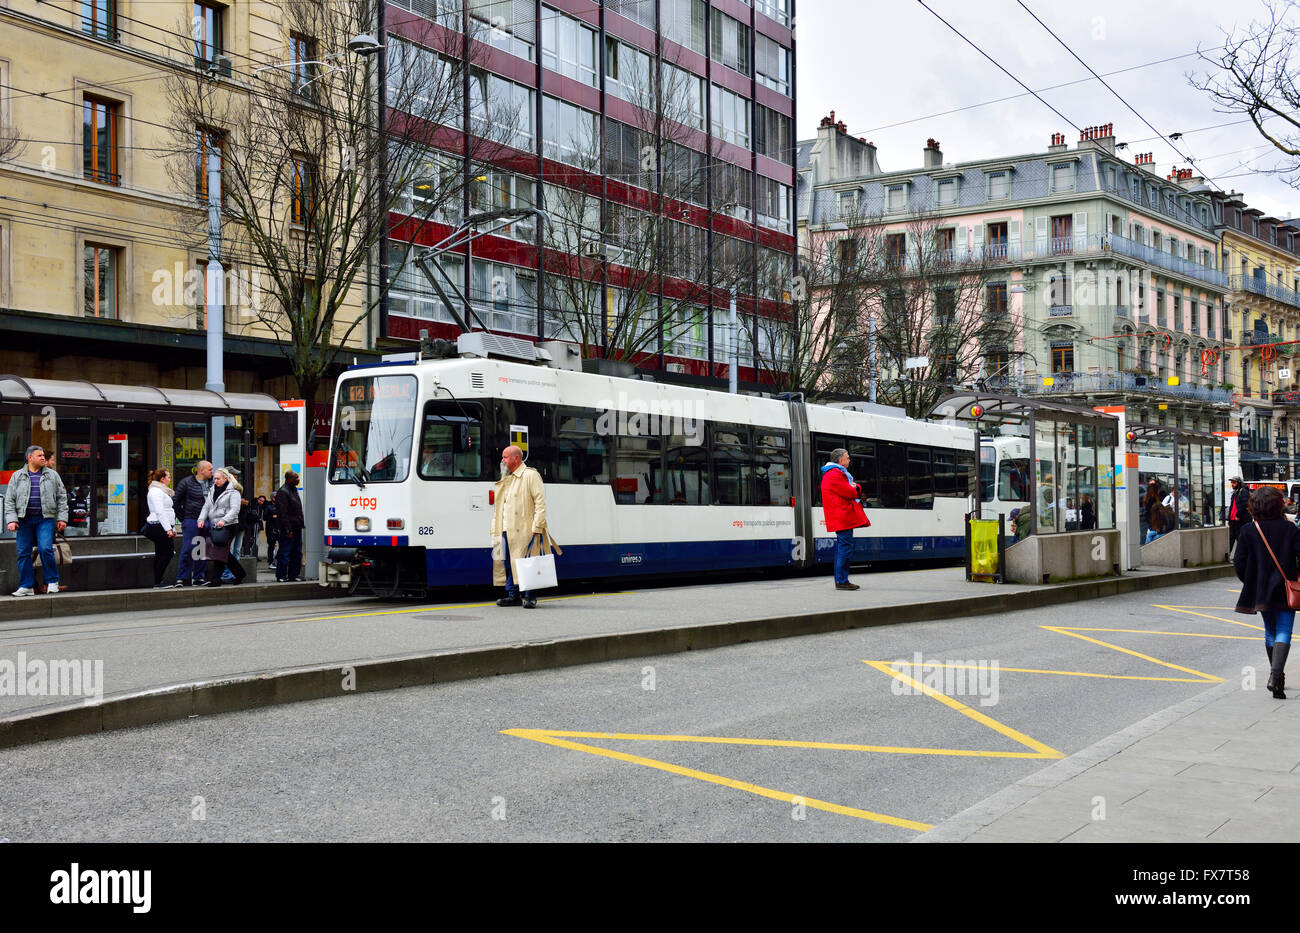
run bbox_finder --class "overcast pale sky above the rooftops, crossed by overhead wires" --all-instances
[796,0,1300,217]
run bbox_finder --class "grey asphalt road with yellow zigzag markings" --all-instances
[0,577,1264,842]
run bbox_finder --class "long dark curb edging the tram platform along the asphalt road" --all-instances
[0,564,1232,753]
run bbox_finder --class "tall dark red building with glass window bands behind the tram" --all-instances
[380,0,796,385]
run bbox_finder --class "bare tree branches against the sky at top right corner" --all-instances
[1187,0,1300,187]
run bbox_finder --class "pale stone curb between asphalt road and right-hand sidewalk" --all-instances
[911,680,1242,842]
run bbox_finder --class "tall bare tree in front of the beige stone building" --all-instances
[159,0,509,421]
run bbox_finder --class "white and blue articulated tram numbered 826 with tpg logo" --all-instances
[321,357,975,594]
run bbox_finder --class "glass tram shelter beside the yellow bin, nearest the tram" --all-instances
[930,392,1121,583]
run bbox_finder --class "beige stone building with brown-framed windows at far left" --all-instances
[0,0,373,534]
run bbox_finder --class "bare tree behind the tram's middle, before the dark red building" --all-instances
[546,50,754,361]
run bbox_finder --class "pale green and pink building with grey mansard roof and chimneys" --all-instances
[798,114,1230,430]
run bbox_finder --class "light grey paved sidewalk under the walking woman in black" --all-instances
[917,680,1300,842]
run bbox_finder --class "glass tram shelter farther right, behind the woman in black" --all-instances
[1125,422,1229,567]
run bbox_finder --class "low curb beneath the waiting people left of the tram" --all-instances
[0,581,341,621]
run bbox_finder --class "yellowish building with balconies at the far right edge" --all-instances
[1213,191,1300,479]
